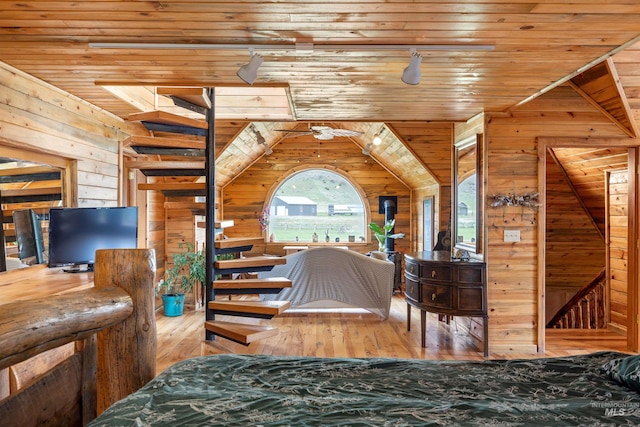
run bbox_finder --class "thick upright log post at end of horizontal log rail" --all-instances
[94,249,157,414]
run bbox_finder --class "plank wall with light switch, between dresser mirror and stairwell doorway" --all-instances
[485,87,624,352]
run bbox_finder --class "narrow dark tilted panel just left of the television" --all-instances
[13,209,45,265]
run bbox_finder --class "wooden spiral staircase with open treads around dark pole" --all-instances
[125,88,291,345]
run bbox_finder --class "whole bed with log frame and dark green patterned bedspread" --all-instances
[0,250,640,427]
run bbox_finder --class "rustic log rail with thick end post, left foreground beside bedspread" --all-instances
[0,249,156,427]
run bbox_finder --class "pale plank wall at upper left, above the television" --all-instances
[0,63,137,206]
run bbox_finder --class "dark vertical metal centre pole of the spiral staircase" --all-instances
[205,88,216,341]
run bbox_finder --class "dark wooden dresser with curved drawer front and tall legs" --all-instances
[404,251,489,357]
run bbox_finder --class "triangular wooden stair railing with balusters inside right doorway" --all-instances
[547,269,607,329]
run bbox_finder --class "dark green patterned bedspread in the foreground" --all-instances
[90,352,640,427]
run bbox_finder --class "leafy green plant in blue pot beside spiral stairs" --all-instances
[157,243,206,316]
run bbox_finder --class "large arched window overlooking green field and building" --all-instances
[267,169,367,243]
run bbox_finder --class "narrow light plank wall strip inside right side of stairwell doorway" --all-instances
[607,171,629,331]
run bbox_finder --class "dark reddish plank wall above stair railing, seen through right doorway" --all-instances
[545,151,604,323]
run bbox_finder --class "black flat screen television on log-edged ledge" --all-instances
[49,207,138,272]
